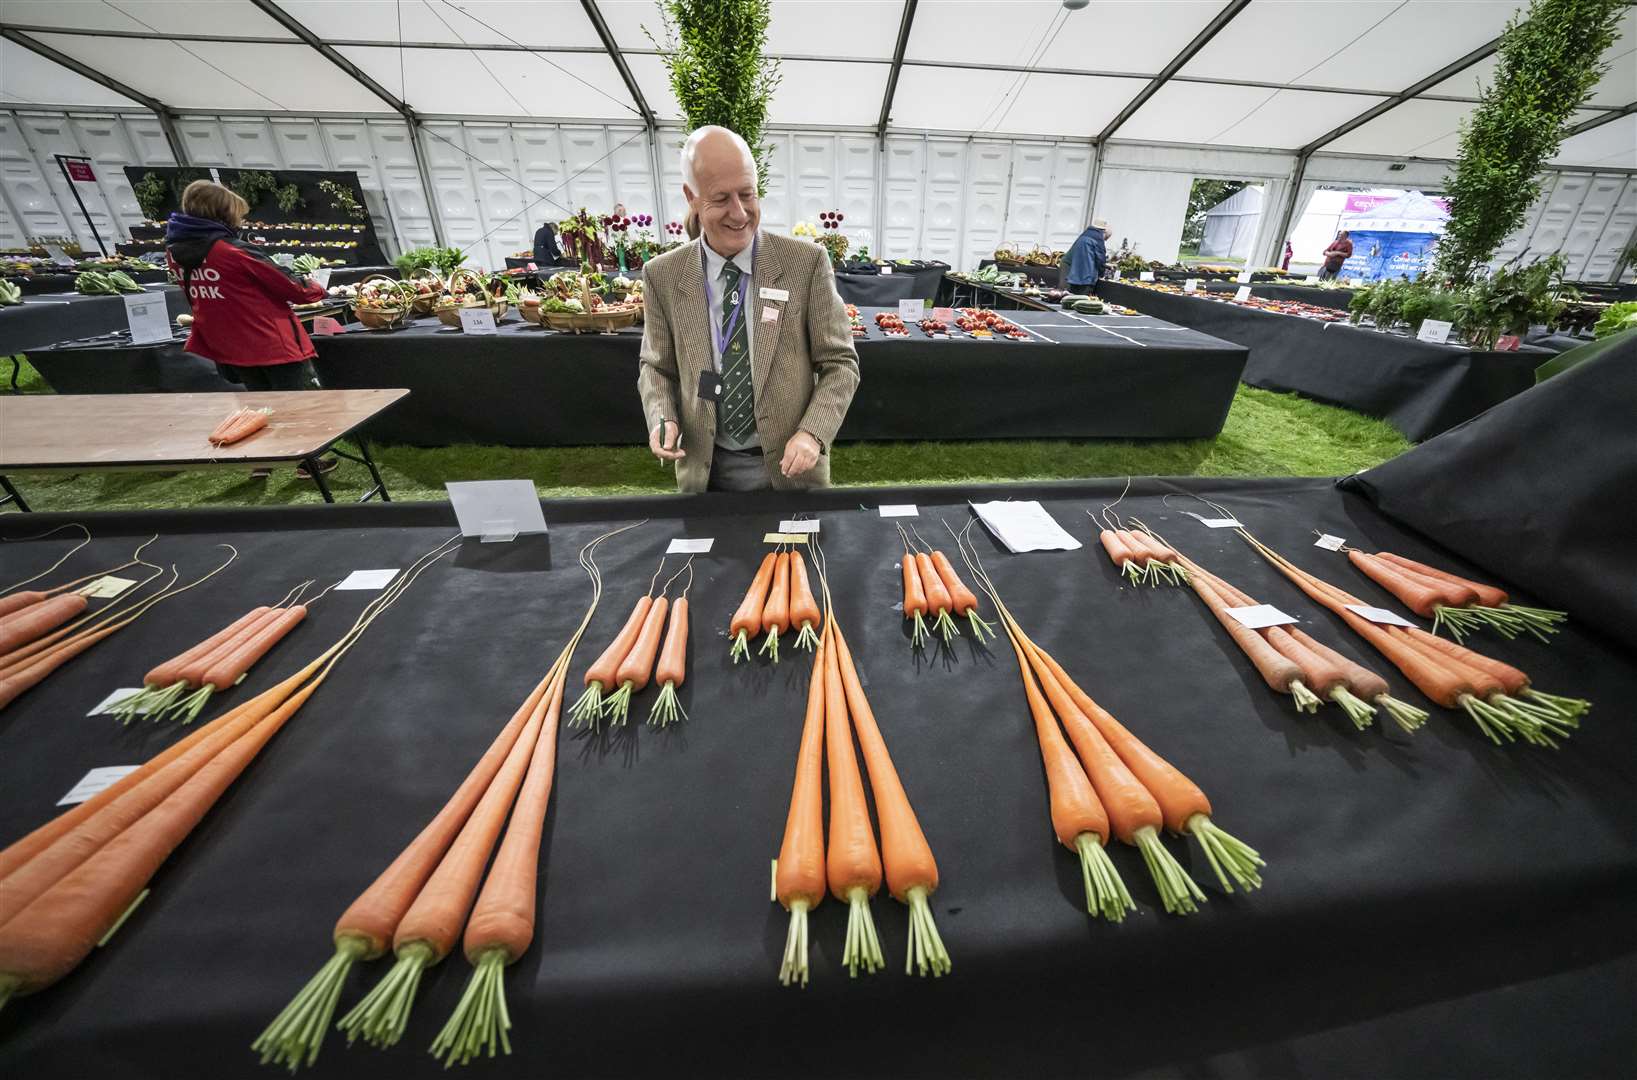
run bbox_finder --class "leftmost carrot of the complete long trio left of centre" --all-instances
[250,525,635,1072]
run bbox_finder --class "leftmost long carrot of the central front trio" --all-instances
[773,632,830,987]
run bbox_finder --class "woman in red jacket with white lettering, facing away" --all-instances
[165,180,336,473]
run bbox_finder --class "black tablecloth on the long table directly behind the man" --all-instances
[314,309,1244,447]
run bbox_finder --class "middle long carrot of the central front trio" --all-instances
[823,610,886,977]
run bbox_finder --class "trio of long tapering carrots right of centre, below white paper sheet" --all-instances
[956,523,1264,921]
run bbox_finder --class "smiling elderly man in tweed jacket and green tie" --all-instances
[637,128,858,491]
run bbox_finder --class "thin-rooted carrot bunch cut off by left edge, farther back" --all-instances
[0,537,239,709]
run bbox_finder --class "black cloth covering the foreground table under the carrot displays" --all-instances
[0,479,1637,1080]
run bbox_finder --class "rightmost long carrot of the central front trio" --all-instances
[830,618,949,977]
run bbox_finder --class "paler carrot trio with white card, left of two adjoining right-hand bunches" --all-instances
[1141,525,1427,731]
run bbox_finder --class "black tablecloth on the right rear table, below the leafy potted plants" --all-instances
[1097,281,1550,442]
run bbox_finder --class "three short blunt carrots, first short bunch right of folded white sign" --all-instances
[568,558,694,728]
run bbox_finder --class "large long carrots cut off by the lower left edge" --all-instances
[0,543,461,1003]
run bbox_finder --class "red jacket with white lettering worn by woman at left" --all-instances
[165,237,326,367]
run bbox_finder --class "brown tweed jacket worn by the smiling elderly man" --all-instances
[637,232,858,491]
